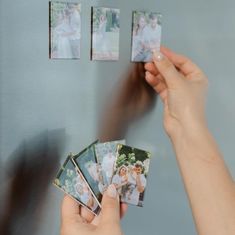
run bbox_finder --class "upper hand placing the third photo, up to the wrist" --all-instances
[145,47,208,139]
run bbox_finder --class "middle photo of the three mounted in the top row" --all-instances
[91,7,120,61]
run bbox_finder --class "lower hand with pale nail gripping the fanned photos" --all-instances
[61,185,127,235]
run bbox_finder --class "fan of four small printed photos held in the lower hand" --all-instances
[54,140,150,215]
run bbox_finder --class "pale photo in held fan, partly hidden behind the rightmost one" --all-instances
[95,140,125,189]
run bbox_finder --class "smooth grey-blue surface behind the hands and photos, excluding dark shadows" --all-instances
[0,0,235,235]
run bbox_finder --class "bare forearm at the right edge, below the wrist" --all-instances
[172,126,235,235]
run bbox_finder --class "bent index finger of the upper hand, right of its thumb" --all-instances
[161,47,202,76]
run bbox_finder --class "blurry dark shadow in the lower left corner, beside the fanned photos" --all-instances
[0,129,65,235]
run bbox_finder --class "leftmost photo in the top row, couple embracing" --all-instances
[49,2,81,59]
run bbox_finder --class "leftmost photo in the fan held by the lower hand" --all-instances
[53,156,100,215]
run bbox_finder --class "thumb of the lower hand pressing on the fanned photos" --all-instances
[101,184,120,227]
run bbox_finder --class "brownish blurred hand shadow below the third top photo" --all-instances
[98,63,157,142]
